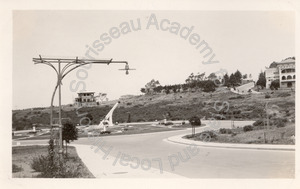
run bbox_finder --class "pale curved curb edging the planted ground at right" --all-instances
[164,135,295,151]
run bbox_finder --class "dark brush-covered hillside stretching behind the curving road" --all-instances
[12,88,295,130]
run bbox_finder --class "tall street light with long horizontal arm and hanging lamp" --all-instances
[32,55,130,154]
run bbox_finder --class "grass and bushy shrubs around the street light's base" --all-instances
[12,142,94,178]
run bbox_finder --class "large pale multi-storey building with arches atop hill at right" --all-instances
[266,58,296,89]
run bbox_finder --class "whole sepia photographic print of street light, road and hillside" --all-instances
[1,1,299,188]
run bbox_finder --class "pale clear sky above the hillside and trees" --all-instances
[13,10,295,109]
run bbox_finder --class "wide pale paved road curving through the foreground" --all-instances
[13,121,295,178]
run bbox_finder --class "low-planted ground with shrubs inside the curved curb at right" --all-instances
[184,120,295,145]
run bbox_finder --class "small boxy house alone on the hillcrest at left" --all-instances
[74,91,97,107]
